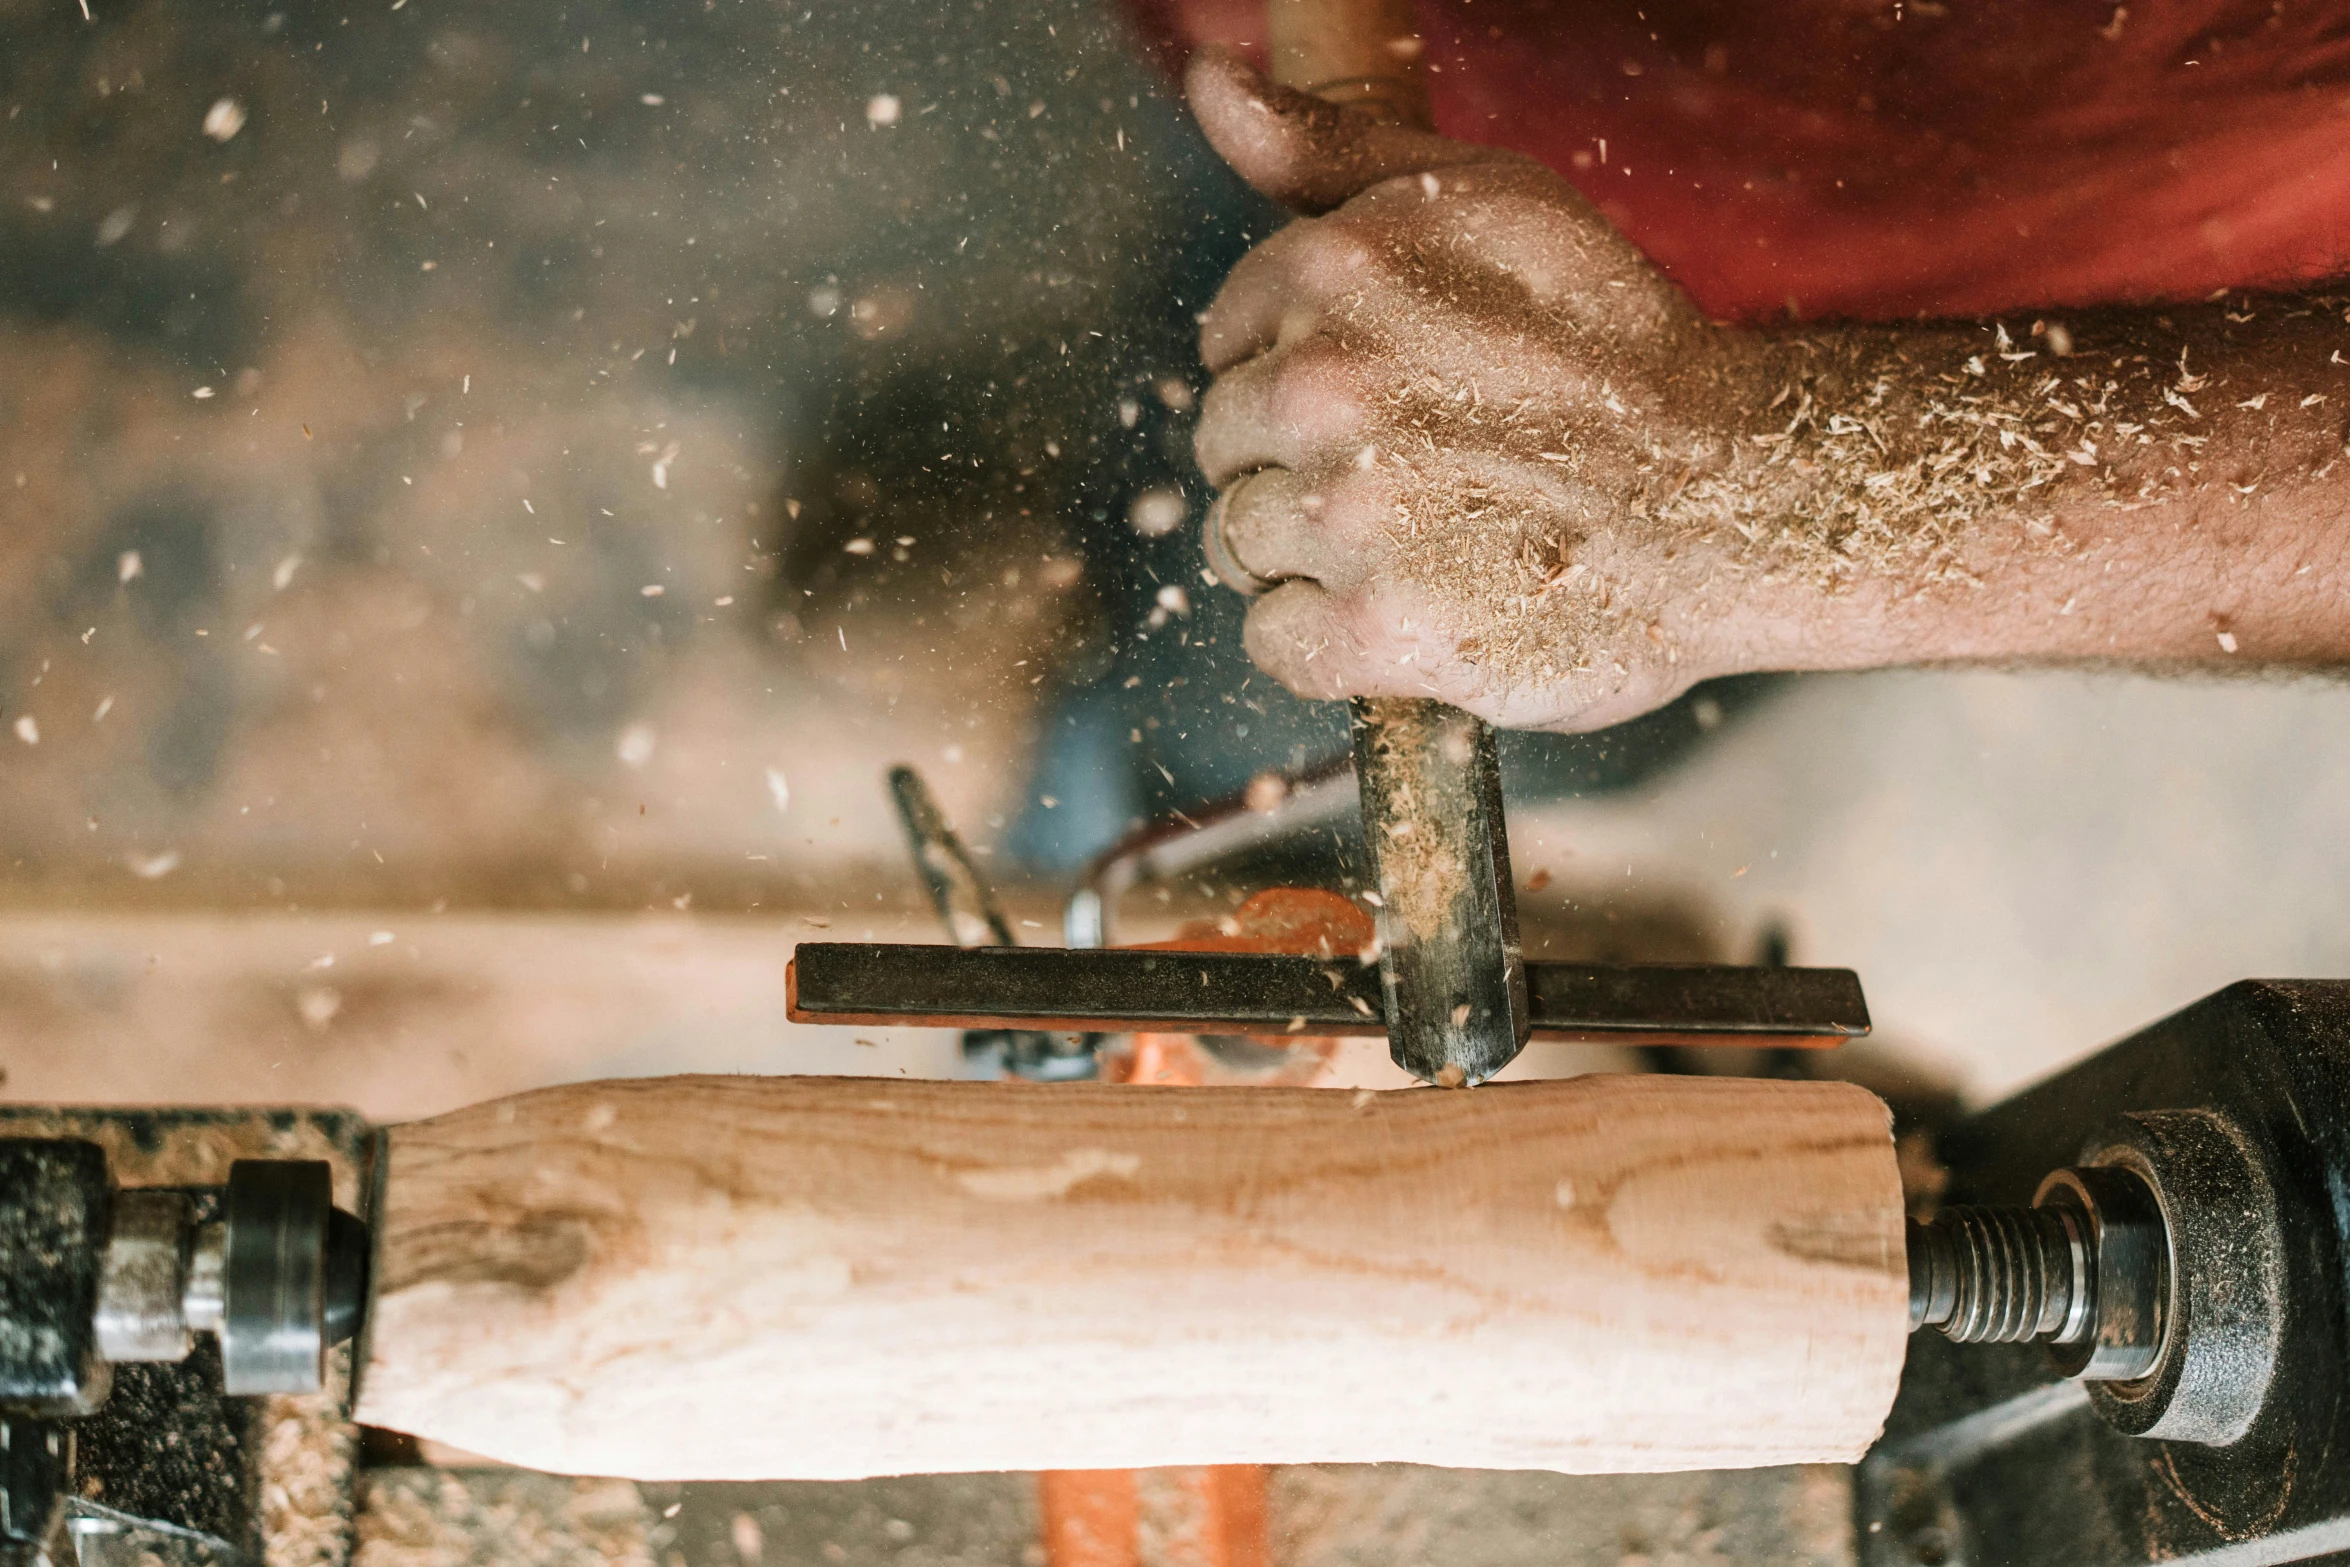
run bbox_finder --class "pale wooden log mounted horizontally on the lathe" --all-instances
[357,1076,1908,1480]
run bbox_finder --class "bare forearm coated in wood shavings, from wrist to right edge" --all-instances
[1701,296,2350,667]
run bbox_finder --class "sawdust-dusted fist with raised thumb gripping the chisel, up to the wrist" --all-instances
[1189,52,1772,728]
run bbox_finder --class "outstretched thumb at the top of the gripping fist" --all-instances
[1184,45,1511,211]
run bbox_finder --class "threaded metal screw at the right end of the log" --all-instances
[1908,1208,2096,1344]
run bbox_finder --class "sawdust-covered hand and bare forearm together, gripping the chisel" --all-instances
[1189,52,2350,728]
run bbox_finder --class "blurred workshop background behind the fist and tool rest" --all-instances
[0,0,2350,1118]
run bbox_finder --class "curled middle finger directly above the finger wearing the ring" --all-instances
[1191,336,1370,489]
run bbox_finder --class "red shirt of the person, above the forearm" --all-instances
[1137,0,2350,320]
